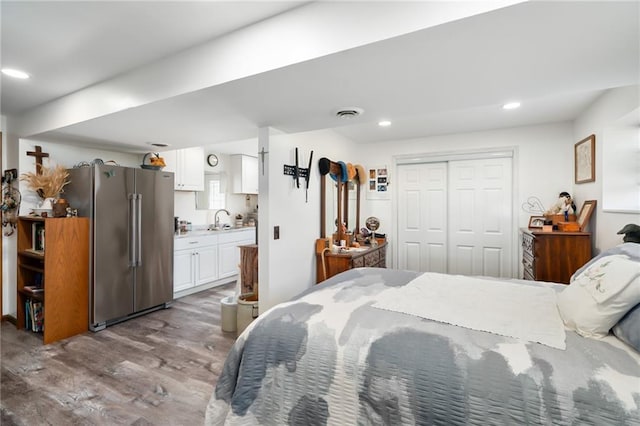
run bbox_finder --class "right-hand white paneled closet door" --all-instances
[448,158,513,278]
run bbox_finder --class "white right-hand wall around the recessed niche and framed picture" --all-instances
[573,86,640,251]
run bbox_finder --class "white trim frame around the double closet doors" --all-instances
[390,146,521,278]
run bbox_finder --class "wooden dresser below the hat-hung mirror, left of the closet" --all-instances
[316,241,387,282]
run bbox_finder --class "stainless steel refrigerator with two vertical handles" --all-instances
[63,164,174,331]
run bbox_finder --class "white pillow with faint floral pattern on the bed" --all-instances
[558,255,640,337]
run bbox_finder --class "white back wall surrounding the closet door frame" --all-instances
[350,122,582,272]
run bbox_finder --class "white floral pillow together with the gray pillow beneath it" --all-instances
[558,243,640,351]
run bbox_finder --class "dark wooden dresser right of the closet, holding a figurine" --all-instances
[521,229,591,284]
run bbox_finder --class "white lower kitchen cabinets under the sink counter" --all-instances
[173,228,255,297]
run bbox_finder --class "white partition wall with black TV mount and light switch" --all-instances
[258,129,352,313]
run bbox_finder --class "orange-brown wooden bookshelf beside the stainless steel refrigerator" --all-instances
[16,217,89,344]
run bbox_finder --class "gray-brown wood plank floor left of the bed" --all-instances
[0,284,236,426]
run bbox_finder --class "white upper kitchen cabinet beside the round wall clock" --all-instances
[162,147,204,191]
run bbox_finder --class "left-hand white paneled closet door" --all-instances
[398,162,447,273]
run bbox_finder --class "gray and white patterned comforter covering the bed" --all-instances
[206,268,640,425]
